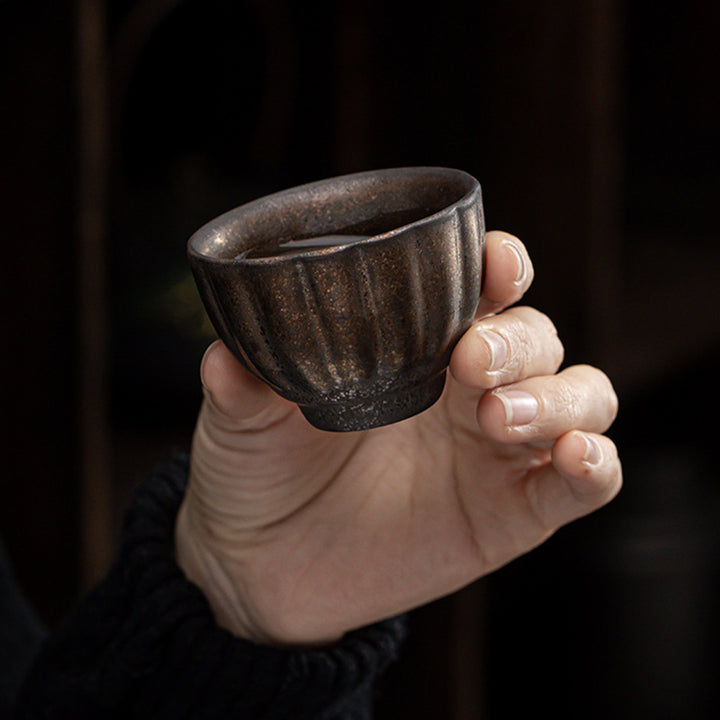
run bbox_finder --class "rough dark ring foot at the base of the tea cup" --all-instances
[300,371,447,432]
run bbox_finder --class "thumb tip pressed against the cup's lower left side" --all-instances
[200,340,297,430]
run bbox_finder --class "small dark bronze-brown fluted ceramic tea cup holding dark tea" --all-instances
[188,167,485,431]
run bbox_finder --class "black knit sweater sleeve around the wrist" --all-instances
[17,456,403,720]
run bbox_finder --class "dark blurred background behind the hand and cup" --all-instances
[0,0,720,720]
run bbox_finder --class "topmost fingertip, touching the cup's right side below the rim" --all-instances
[475,230,535,319]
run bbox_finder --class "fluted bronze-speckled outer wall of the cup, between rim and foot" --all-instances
[191,166,484,429]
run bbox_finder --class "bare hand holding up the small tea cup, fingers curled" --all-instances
[176,232,622,644]
